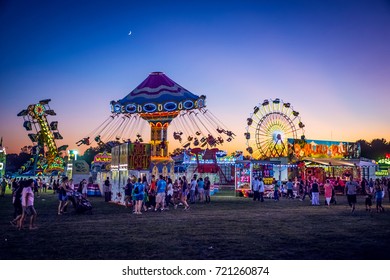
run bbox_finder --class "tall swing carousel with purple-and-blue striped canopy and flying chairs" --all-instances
[77,72,235,158]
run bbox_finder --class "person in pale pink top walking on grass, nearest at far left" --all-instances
[18,179,37,230]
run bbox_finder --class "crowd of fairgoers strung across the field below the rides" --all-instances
[1,175,390,230]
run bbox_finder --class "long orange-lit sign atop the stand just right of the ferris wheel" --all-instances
[287,138,360,160]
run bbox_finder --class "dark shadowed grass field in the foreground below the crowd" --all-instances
[0,188,390,260]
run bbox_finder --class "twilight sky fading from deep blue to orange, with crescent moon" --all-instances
[0,0,390,153]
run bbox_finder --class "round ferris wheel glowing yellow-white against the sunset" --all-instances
[245,98,305,159]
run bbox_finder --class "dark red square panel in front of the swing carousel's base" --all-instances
[128,143,151,170]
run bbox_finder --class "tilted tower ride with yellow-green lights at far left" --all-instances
[17,99,67,176]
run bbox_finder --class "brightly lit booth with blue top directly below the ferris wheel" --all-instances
[235,160,280,197]
